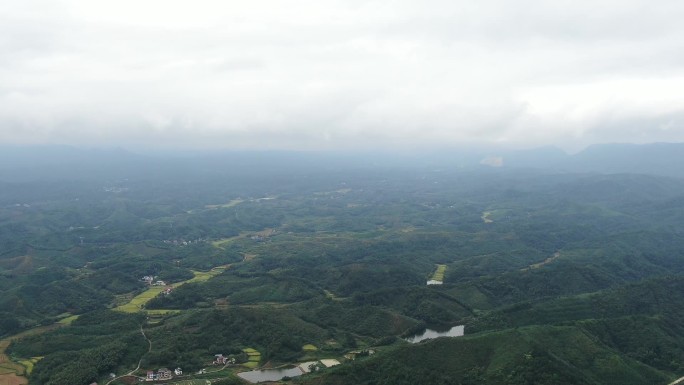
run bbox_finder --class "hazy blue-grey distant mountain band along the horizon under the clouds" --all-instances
[0,143,684,181]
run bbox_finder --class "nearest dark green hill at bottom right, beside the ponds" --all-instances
[304,326,670,385]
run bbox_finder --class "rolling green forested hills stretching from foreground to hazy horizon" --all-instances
[0,145,684,385]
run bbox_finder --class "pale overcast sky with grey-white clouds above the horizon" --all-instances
[0,0,684,149]
